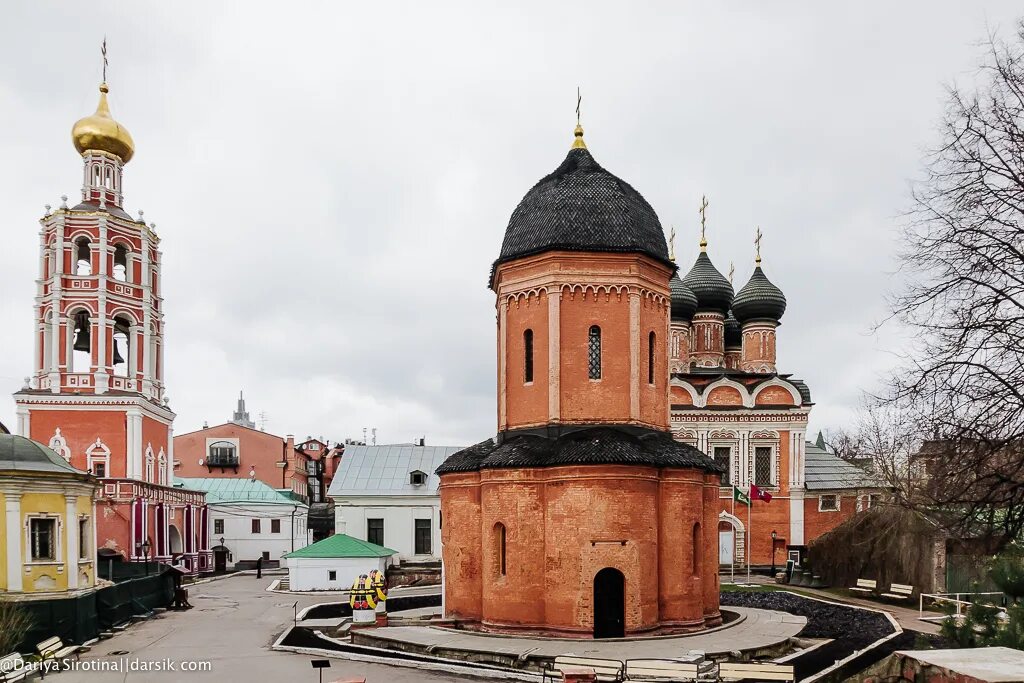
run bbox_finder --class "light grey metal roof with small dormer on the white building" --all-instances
[327,445,463,498]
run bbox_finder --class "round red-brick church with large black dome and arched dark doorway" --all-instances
[437,127,721,638]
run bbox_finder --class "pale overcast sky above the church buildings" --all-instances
[0,1,1021,445]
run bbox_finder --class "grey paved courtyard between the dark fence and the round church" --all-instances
[55,575,472,683]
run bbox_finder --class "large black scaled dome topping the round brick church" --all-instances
[492,147,675,280]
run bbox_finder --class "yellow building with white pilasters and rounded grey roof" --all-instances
[0,434,98,597]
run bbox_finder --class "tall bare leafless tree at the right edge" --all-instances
[883,22,1024,539]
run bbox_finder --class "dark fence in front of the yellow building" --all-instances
[18,563,176,653]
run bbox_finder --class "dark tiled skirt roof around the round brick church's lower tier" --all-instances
[437,427,721,474]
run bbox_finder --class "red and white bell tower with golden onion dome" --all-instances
[14,77,212,575]
